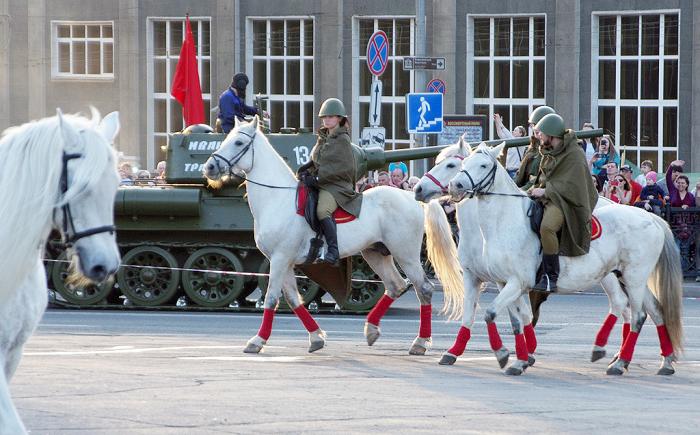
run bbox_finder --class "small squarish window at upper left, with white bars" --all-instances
[51,21,114,80]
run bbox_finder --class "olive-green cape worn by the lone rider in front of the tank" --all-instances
[309,126,362,216]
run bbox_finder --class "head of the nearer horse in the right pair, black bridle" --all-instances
[448,142,505,201]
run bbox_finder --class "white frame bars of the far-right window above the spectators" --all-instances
[591,9,683,172]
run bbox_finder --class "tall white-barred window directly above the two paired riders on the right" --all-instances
[467,16,546,139]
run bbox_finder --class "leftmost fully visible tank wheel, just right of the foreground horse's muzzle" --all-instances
[117,246,180,307]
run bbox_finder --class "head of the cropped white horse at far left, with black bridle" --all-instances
[53,110,120,282]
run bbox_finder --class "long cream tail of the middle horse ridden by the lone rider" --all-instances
[424,200,464,319]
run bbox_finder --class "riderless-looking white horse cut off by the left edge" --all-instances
[0,111,120,434]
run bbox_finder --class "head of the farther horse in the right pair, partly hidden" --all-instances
[413,137,471,202]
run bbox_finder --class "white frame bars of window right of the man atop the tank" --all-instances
[245,15,316,129]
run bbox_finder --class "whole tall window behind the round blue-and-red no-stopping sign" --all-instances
[346,17,414,150]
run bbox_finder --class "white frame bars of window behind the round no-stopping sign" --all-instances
[351,15,416,150]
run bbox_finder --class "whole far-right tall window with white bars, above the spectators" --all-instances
[591,12,679,171]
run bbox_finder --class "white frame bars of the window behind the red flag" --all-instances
[146,16,212,168]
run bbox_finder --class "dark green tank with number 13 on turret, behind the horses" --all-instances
[46,112,602,312]
